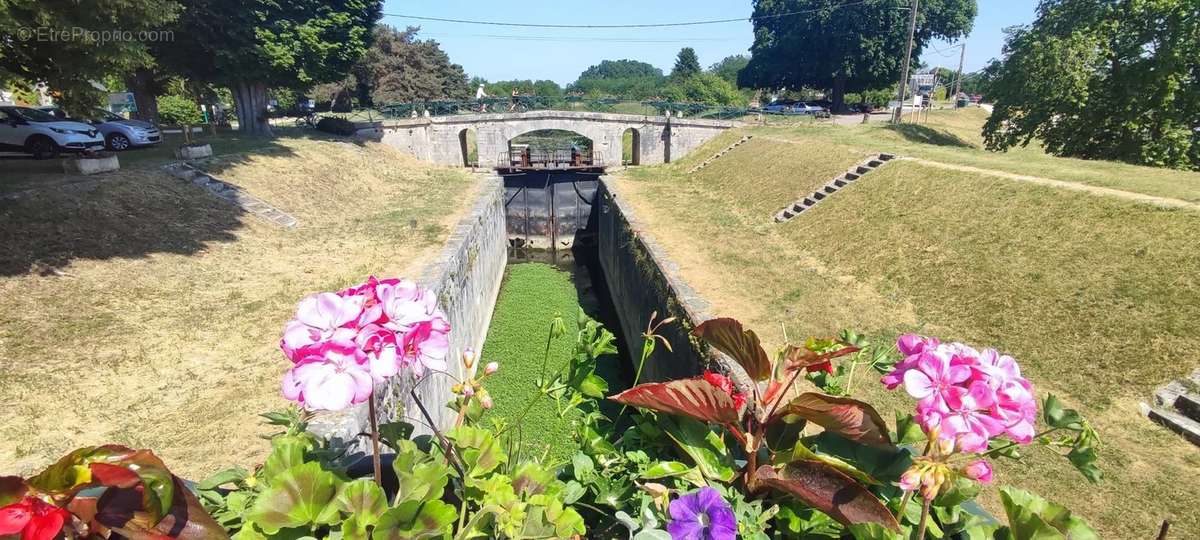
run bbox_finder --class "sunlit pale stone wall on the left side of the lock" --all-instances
[310,176,508,454]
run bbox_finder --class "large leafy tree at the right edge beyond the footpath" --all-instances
[984,0,1200,169]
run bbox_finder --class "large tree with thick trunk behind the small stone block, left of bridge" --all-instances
[156,0,380,134]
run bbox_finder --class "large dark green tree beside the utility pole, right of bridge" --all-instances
[738,0,977,109]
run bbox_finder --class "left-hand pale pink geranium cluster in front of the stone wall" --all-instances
[280,276,450,410]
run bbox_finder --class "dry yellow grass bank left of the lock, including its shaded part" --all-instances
[0,138,474,478]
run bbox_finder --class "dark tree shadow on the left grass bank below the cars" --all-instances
[0,172,244,278]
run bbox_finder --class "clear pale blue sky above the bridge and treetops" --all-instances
[384,0,1037,84]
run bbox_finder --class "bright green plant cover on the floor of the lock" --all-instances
[481,263,592,461]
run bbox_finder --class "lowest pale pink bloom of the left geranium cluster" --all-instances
[283,341,373,410]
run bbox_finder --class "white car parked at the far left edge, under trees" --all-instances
[0,107,104,160]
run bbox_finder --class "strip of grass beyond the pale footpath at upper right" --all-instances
[750,108,1200,202]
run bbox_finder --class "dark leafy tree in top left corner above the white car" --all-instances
[0,0,180,112]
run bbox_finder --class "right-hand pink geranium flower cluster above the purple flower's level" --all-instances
[882,334,1038,454]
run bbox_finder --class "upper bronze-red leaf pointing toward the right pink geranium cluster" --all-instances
[768,392,892,446]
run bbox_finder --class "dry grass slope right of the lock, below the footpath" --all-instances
[618,108,1200,538]
